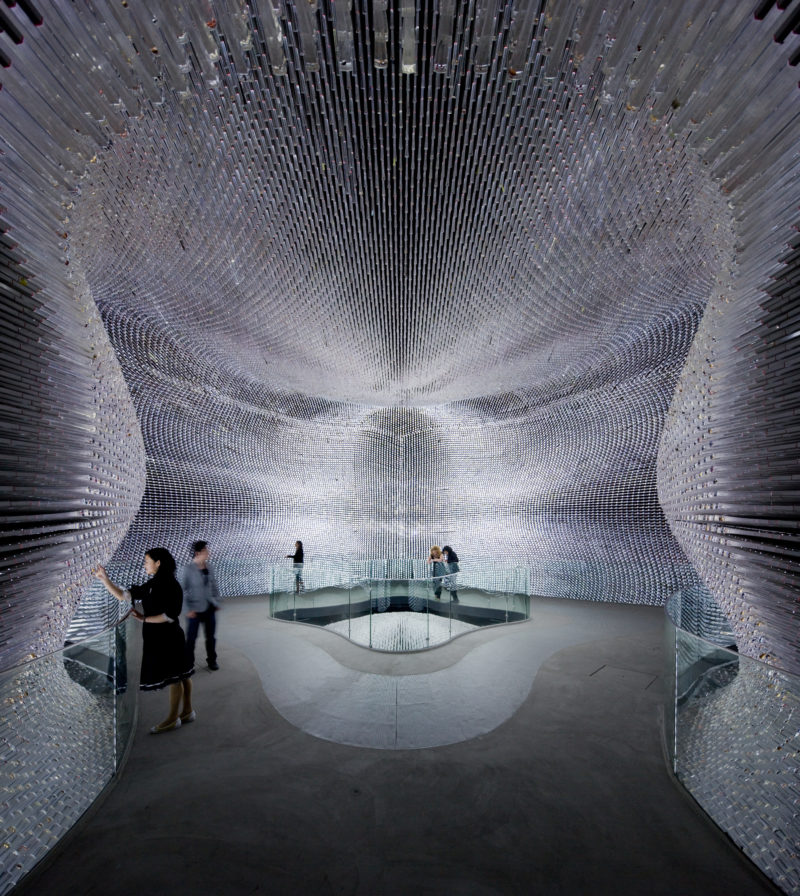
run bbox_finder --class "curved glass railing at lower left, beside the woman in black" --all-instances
[0,621,136,894]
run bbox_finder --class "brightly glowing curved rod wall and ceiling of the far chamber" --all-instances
[72,0,733,616]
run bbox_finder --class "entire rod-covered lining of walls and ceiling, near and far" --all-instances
[0,0,800,692]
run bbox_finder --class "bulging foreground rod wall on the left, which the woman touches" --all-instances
[0,47,145,669]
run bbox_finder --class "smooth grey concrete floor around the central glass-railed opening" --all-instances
[17,599,778,896]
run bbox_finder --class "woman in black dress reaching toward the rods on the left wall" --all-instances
[95,548,195,734]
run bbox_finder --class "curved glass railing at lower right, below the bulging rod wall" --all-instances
[665,606,800,893]
